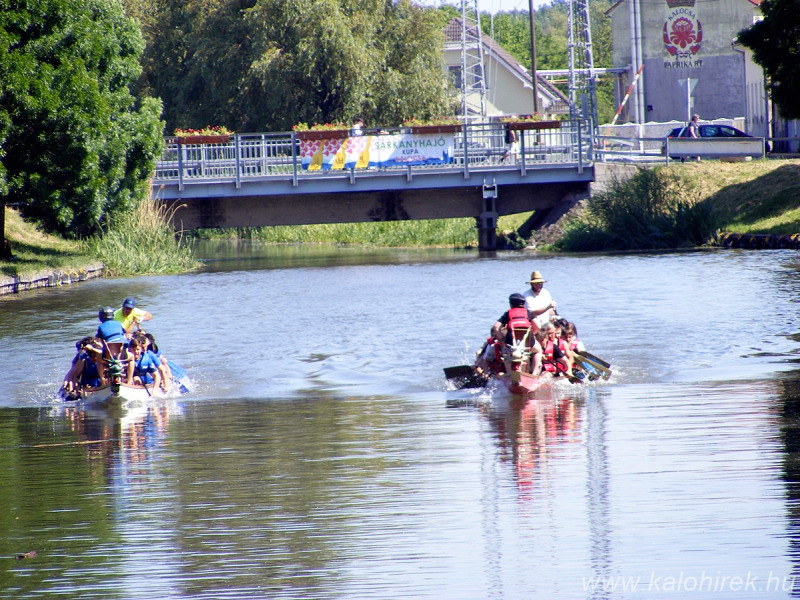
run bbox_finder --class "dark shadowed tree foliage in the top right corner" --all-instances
[739,0,800,119]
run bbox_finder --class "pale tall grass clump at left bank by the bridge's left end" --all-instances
[89,198,200,275]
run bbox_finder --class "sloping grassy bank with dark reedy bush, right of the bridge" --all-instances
[554,160,800,251]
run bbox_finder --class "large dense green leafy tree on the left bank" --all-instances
[0,0,163,237]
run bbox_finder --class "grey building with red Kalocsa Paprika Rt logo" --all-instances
[607,0,771,137]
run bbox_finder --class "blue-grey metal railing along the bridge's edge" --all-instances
[154,119,594,189]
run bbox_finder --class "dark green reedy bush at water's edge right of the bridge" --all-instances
[556,167,715,251]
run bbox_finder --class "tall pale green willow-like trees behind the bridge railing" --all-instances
[133,0,452,131]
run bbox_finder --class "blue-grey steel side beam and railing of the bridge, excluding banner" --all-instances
[153,120,592,199]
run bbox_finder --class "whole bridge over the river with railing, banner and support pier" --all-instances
[153,120,594,250]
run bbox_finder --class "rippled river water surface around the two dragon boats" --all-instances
[0,247,800,600]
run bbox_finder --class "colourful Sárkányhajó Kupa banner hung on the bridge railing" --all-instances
[299,133,455,171]
